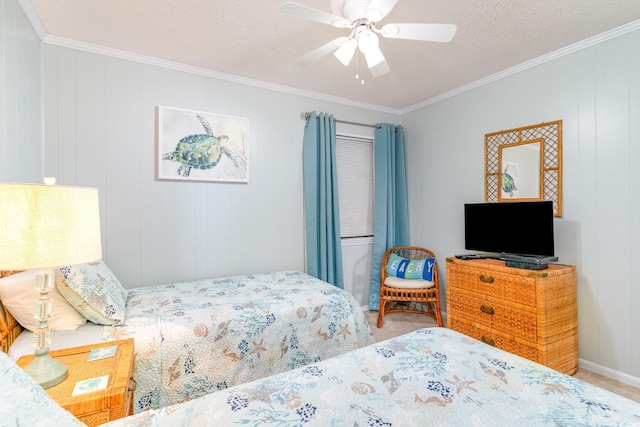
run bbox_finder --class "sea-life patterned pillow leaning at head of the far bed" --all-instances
[56,260,127,325]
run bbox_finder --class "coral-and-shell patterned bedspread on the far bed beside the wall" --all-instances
[103,272,374,412]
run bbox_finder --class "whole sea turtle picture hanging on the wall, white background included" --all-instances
[157,106,249,183]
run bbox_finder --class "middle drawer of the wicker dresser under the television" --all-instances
[447,291,538,342]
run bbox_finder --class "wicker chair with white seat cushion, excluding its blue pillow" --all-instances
[378,246,442,328]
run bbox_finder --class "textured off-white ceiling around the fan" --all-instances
[27,0,640,110]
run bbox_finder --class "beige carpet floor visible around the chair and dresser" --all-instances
[365,311,640,402]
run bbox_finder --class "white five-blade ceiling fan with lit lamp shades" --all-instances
[278,0,456,77]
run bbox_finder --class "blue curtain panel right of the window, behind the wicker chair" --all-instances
[369,123,409,310]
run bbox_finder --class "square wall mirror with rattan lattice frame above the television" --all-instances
[484,120,562,216]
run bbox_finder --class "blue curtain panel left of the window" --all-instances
[302,111,344,289]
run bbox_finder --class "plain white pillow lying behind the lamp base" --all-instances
[0,270,87,332]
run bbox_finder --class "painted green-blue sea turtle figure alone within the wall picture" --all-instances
[162,114,246,177]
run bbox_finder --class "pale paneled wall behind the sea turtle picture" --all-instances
[44,45,399,298]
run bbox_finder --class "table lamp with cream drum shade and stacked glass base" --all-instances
[0,179,102,388]
